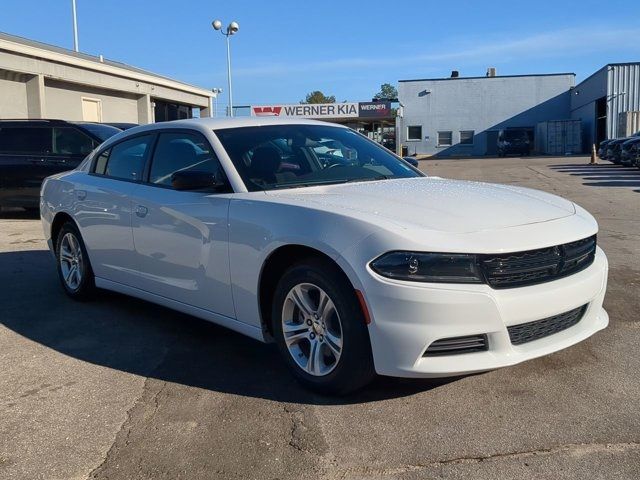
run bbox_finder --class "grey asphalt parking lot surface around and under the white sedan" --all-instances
[0,157,640,480]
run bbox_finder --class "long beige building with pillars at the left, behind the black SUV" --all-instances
[0,33,213,124]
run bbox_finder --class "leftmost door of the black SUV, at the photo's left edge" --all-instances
[0,122,56,207]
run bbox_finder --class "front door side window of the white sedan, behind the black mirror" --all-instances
[149,132,220,186]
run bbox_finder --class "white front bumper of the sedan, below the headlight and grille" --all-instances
[364,248,609,377]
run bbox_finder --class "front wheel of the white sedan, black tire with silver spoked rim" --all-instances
[271,260,375,395]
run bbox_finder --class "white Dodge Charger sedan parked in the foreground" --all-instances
[41,118,608,394]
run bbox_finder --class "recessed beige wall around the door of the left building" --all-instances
[44,79,139,123]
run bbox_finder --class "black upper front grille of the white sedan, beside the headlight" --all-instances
[480,235,596,288]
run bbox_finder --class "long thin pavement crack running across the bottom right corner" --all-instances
[337,442,640,480]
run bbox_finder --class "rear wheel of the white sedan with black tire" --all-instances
[55,222,95,300]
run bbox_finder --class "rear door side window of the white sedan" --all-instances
[95,135,152,180]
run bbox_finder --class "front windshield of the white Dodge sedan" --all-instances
[215,125,422,191]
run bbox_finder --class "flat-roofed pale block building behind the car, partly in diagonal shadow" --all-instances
[398,69,575,156]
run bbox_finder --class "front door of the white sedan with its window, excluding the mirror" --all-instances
[127,130,235,318]
